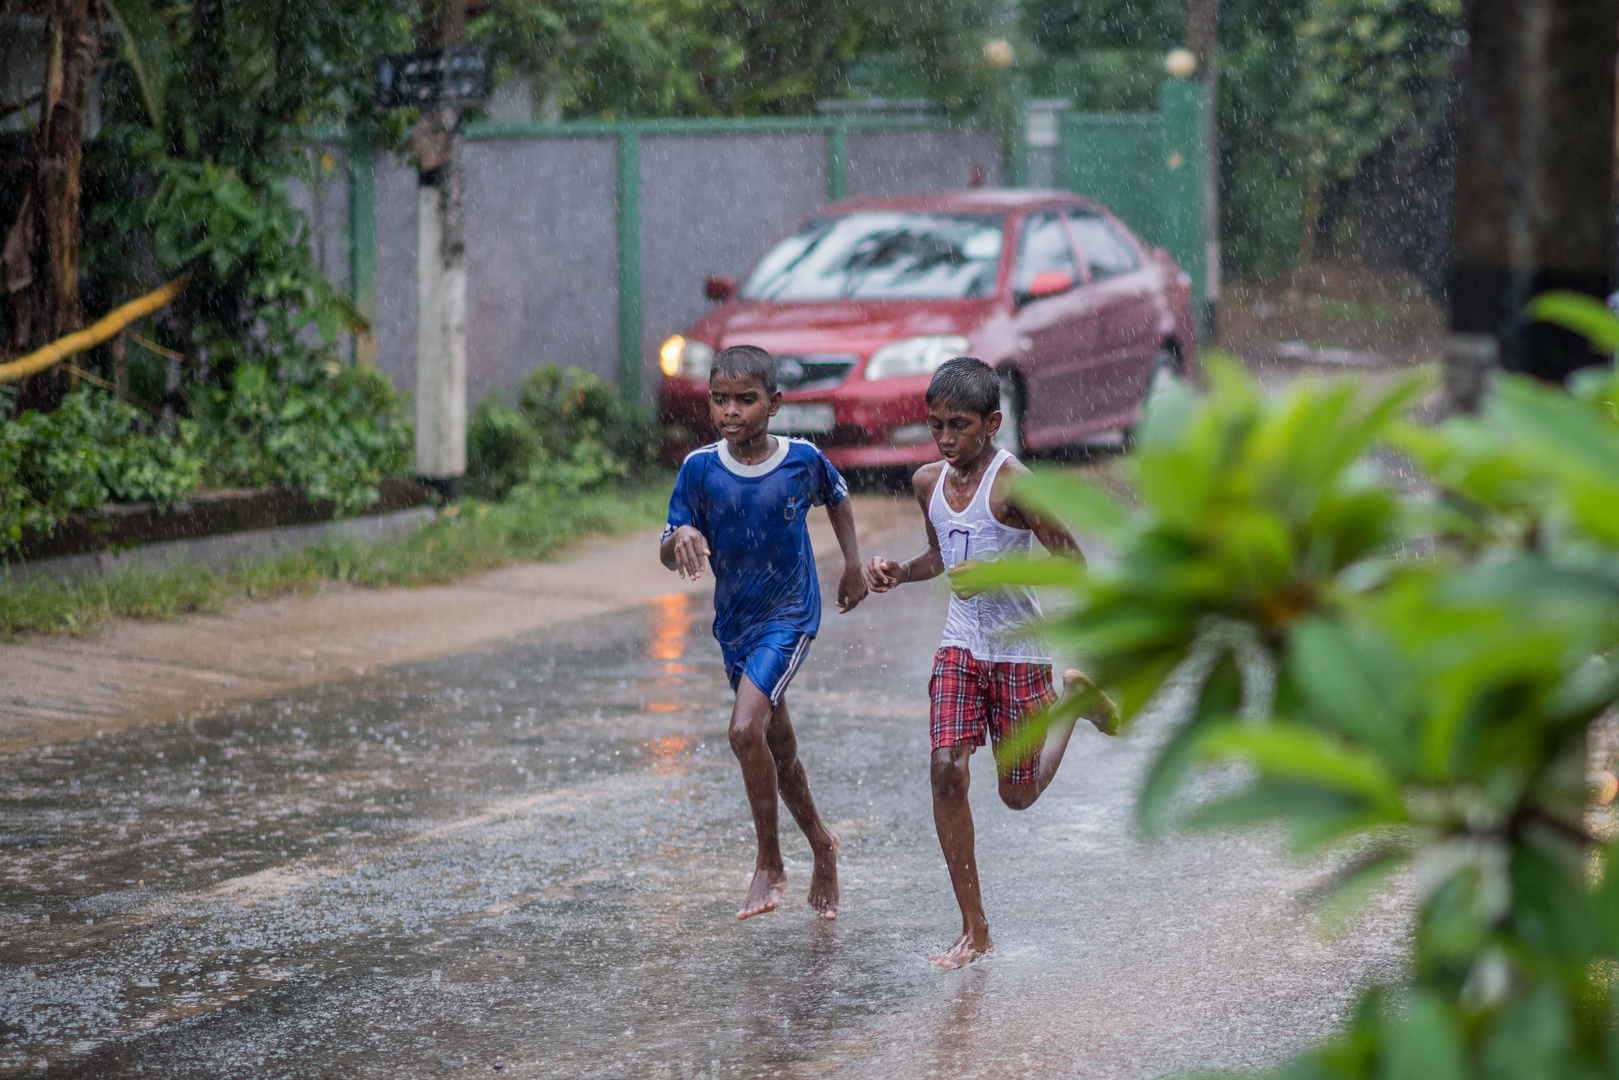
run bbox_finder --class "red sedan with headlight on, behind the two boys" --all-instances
[659,189,1196,468]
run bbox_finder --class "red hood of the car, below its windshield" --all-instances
[691,300,994,356]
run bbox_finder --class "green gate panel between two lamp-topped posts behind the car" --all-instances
[1062,113,1164,244]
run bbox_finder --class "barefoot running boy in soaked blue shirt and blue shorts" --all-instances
[659,345,866,918]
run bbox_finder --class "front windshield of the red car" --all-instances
[742,210,1004,300]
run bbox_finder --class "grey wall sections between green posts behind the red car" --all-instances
[305,130,1001,403]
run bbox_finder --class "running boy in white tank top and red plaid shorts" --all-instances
[866,356,1117,968]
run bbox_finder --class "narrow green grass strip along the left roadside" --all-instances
[0,479,670,640]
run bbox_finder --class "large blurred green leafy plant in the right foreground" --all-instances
[984,325,1619,1080]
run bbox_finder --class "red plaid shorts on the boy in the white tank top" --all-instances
[928,644,1057,784]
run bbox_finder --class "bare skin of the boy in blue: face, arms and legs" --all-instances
[659,376,866,920]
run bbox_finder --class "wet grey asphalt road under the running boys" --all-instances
[0,563,1405,1080]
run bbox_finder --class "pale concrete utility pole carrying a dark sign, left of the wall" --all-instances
[411,0,466,500]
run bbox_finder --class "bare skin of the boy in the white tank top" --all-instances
[866,400,1117,968]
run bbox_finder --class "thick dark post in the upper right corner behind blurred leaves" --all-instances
[1446,0,1619,411]
